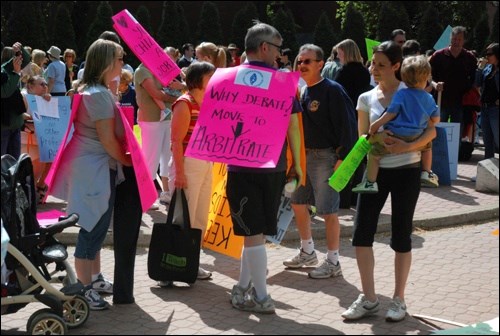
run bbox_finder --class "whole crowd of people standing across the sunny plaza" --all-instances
[1,22,499,321]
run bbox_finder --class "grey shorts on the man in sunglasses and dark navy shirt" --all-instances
[291,148,340,215]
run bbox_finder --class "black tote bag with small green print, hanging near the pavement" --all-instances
[148,189,201,283]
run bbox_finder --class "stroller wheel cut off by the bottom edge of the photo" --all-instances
[26,308,68,335]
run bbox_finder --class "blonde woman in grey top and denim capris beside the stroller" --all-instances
[50,39,132,310]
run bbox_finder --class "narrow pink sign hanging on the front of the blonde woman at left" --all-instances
[119,107,158,212]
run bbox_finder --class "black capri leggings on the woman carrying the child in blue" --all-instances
[352,167,420,253]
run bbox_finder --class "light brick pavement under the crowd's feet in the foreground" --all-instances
[2,220,499,335]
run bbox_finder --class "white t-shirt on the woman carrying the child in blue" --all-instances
[356,82,421,168]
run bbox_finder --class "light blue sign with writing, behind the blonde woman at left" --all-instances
[26,94,73,162]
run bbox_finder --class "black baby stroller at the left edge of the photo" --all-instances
[1,154,90,335]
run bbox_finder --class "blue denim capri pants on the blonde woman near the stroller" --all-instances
[74,169,116,260]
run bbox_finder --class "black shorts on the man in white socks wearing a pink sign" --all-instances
[226,172,286,236]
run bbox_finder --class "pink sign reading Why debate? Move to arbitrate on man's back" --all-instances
[186,65,299,168]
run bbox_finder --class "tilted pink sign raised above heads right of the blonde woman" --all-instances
[112,9,181,86]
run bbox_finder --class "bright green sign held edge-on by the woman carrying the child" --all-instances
[328,135,372,192]
